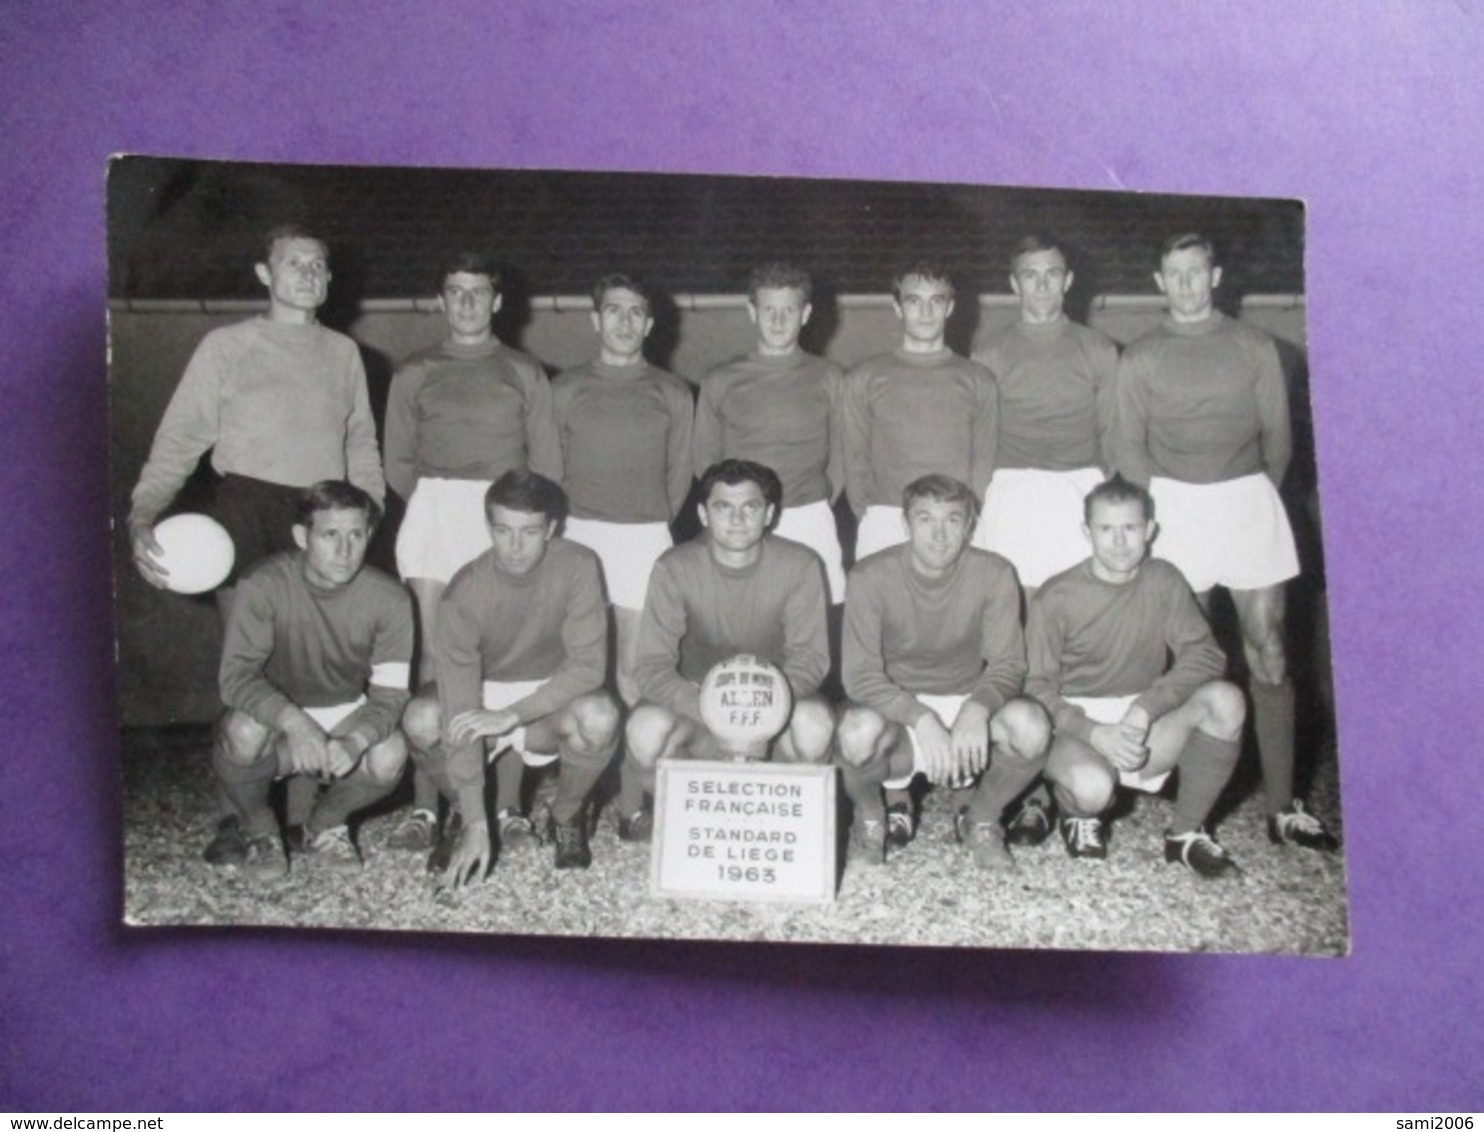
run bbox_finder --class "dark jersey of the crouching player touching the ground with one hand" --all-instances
[435,539,608,815]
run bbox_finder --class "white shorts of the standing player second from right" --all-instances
[974,467,1103,586]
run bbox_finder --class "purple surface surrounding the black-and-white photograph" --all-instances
[0,0,1484,1113]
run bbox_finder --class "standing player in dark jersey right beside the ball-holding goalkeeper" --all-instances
[386,252,561,850]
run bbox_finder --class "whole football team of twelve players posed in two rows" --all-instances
[129,233,1334,883]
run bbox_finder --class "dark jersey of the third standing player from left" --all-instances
[552,361,695,522]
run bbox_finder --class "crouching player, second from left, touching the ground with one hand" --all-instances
[405,472,619,889]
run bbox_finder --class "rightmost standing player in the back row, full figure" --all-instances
[1116,233,1339,850]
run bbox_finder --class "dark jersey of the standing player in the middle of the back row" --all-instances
[695,349,844,507]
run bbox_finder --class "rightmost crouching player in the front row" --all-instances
[1025,478,1247,877]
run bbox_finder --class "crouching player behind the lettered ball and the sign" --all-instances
[619,460,834,841]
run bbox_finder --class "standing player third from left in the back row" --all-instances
[552,274,695,706]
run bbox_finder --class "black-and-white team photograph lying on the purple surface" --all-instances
[108,157,1349,955]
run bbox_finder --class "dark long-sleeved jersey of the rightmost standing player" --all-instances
[1114,312,1293,485]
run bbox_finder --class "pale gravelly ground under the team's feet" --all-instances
[123,728,1349,955]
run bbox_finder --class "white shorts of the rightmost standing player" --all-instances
[1149,473,1299,593]
